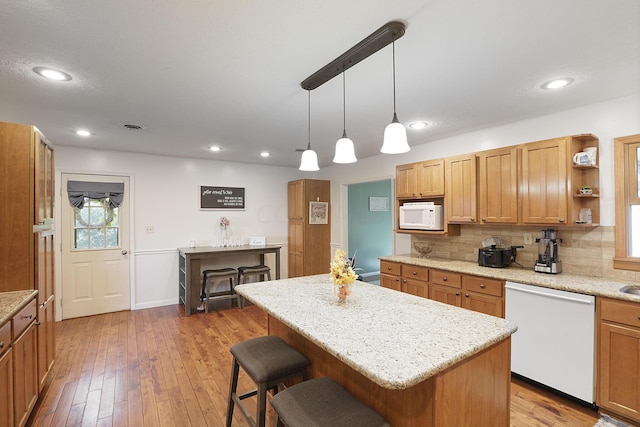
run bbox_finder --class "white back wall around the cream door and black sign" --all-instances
[55,146,299,313]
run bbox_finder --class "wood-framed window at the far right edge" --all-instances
[613,134,640,271]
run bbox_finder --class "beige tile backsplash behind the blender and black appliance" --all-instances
[411,225,640,281]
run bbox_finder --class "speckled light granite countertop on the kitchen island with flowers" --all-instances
[236,274,517,389]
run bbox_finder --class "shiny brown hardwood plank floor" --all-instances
[29,303,597,427]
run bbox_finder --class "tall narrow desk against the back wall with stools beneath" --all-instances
[178,245,282,316]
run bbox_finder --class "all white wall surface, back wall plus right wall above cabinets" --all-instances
[56,94,640,313]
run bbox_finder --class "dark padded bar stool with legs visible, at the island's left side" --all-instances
[227,335,309,427]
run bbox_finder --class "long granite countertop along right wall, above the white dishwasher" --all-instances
[380,255,640,302]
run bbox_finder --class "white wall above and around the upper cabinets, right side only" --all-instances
[320,94,640,247]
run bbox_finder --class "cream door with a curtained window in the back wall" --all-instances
[61,174,131,319]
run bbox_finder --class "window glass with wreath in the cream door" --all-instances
[73,197,120,249]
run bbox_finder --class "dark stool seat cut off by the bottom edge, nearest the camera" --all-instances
[271,377,389,427]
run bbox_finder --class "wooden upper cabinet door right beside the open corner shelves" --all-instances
[522,138,567,224]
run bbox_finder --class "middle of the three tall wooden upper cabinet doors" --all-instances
[478,147,518,224]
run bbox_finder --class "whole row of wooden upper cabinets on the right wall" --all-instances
[396,134,600,235]
